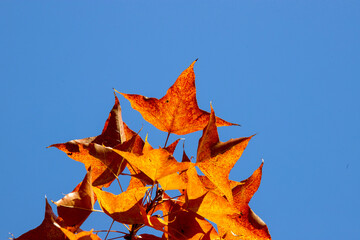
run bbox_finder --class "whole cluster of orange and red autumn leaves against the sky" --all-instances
[16,61,271,240]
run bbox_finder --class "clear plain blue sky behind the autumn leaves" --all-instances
[0,0,360,240]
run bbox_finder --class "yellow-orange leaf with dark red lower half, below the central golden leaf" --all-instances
[94,187,148,224]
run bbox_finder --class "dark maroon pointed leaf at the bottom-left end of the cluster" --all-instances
[14,198,68,240]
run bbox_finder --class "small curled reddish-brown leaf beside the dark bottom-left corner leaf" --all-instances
[55,169,95,229]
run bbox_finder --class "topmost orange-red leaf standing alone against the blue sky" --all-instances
[116,60,237,135]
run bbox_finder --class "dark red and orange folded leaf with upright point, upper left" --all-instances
[49,95,142,187]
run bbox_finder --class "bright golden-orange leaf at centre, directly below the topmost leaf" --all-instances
[113,148,191,181]
